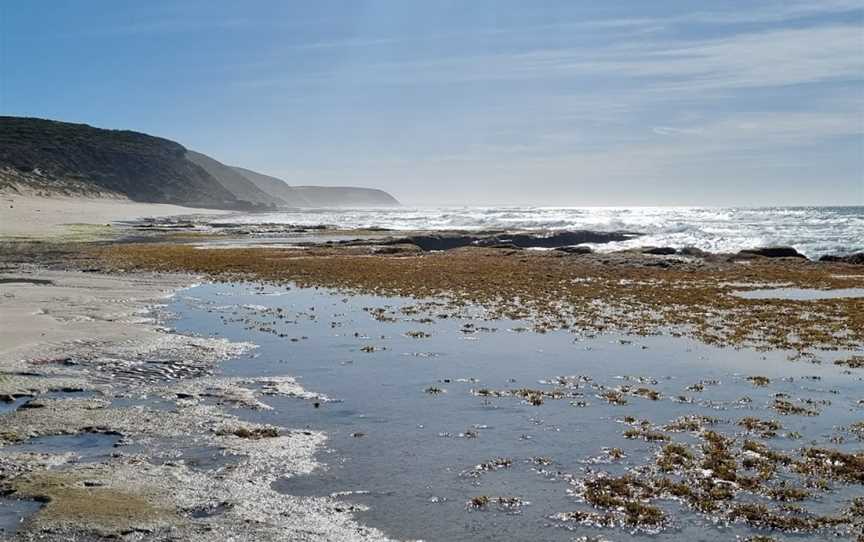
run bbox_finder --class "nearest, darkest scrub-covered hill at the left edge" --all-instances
[0,117,251,209]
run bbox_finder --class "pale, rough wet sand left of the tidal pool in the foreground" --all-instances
[0,265,385,541]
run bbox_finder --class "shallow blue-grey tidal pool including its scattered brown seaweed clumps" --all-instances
[172,283,864,540]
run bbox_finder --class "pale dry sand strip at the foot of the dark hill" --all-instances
[0,194,230,239]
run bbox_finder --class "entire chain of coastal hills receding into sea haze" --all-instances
[0,116,398,211]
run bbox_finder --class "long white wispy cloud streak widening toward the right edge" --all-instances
[352,25,864,90]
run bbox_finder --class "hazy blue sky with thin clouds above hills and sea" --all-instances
[0,0,864,206]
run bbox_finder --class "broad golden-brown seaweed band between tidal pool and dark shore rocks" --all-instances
[93,243,864,352]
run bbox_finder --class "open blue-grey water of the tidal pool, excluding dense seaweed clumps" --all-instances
[173,284,862,540]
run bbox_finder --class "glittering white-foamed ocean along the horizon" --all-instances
[211,206,864,258]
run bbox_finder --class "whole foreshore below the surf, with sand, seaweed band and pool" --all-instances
[0,199,864,540]
